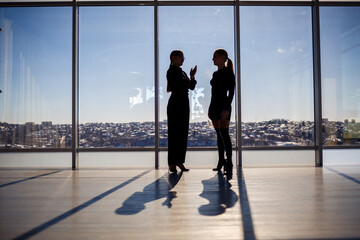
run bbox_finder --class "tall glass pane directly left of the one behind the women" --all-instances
[79,6,155,147]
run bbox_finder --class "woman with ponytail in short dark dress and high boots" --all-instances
[208,49,235,175]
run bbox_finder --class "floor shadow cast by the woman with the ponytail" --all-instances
[199,172,238,216]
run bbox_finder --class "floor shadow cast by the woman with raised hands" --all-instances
[115,172,182,215]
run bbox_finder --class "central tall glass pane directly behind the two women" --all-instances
[159,6,235,146]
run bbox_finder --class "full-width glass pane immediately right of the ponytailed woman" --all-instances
[240,6,314,146]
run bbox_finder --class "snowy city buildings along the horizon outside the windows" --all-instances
[0,119,360,149]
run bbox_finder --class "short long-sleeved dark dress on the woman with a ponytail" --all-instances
[209,67,235,120]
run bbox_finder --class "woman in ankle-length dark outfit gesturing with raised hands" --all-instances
[166,50,197,173]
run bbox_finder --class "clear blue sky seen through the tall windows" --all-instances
[0,6,360,123]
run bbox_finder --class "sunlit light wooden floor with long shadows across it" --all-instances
[0,166,360,240]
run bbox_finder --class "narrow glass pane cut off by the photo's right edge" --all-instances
[320,7,360,145]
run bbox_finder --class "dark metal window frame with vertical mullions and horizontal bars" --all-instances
[0,0,360,169]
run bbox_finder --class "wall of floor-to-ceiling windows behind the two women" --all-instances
[0,0,360,167]
